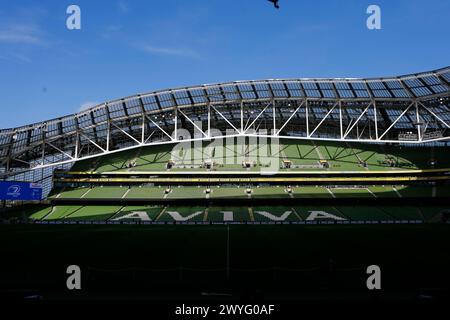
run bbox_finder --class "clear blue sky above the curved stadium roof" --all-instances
[0,0,450,128]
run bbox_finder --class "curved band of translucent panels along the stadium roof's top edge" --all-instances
[0,67,450,134]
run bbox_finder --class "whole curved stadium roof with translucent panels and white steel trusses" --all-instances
[0,67,450,193]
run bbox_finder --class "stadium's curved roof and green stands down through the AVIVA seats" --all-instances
[0,68,450,222]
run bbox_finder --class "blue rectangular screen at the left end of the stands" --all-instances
[0,181,42,200]
